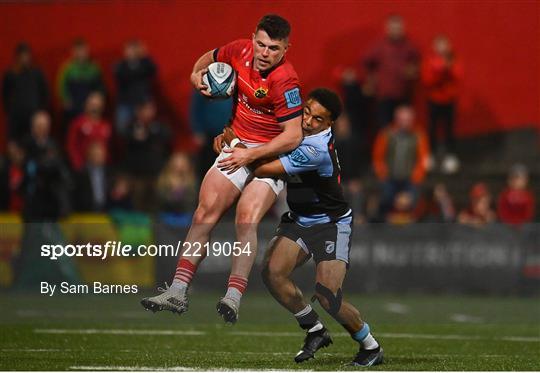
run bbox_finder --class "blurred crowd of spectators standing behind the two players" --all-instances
[0,15,535,226]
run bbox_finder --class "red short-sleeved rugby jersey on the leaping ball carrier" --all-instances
[214,39,302,143]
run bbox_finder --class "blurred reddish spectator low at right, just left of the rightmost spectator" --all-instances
[458,183,495,227]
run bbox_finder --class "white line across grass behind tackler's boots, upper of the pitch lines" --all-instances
[34,329,540,342]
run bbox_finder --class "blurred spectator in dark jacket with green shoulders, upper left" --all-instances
[58,39,105,123]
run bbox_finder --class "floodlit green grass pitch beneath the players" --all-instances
[0,292,540,371]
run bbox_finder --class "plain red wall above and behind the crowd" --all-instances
[0,0,540,150]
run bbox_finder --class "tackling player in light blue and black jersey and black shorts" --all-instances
[225,88,383,366]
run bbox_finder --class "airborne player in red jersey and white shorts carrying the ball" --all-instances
[141,15,303,323]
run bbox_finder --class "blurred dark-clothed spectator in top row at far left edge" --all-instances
[2,43,49,141]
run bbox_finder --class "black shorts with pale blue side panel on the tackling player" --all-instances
[276,212,352,268]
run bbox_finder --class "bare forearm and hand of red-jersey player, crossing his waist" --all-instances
[218,116,303,173]
